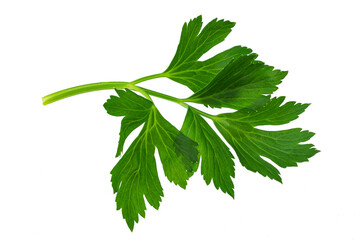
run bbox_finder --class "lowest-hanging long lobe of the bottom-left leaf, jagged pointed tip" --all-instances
[111,124,164,231]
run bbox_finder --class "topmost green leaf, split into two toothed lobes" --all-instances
[164,16,251,92]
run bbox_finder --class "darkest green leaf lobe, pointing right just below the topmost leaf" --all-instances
[186,54,287,109]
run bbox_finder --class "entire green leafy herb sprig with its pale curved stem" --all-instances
[43,16,318,230]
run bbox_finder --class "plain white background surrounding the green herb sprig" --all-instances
[0,0,360,240]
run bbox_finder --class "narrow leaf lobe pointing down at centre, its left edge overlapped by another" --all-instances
[181,107,235,197]
